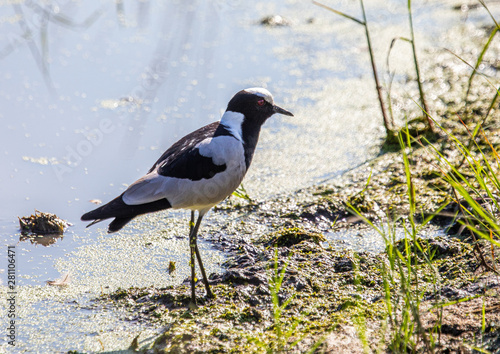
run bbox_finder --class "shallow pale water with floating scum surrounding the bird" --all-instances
[0,0,495,351]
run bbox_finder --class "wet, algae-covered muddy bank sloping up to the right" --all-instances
[96,20,500,353]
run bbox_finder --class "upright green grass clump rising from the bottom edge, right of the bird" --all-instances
[350,129,444,353]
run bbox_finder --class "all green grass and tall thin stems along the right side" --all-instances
[313,0,500,353]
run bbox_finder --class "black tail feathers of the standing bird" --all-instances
[81,194,172,232]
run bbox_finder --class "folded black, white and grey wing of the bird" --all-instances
[122,126,244,208]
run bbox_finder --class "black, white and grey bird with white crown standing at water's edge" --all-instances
[81,87,293,306]
